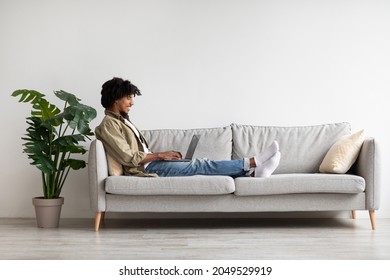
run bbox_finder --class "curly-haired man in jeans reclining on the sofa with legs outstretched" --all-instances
[95,78,280,177]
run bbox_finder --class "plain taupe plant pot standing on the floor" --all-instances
[32,197,64,228]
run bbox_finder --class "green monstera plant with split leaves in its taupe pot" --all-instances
[12,89,96,228]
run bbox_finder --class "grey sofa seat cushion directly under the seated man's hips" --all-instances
[105,176,235,195]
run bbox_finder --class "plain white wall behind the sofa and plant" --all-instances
[0,0,390,218]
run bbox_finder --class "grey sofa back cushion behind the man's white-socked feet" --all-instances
[231,122,351,174]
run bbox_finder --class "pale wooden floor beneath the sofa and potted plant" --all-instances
[0,218,390,260]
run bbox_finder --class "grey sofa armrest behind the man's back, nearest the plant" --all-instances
[88,139,108,212]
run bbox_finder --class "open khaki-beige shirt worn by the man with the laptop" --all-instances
[95,110,157,177]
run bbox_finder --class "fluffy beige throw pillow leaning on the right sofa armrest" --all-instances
[320,130,365,174]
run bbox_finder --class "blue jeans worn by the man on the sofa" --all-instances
[146,158,250,178]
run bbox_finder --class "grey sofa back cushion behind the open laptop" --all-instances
[142,126,232,160]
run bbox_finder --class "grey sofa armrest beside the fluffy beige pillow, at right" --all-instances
[354,138,380,210]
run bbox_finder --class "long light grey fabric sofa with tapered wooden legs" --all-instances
[88,123,380,231]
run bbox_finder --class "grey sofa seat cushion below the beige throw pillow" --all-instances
[234,173,365,196]
